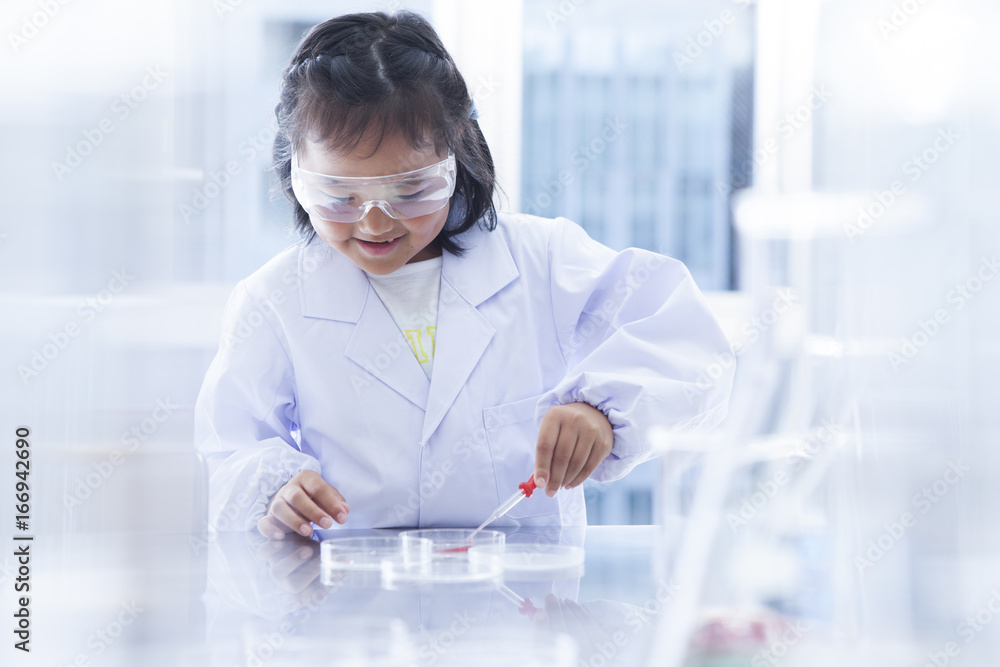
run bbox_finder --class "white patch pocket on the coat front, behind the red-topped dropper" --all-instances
[483,394,559,519]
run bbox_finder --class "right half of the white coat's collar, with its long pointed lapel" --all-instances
[420,227,518,444]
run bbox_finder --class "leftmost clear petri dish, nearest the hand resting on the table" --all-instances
[320,535,433,573]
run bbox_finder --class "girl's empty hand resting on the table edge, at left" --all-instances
[257,470,351,540]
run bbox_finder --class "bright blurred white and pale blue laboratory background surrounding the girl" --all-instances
[0,0,1000,664]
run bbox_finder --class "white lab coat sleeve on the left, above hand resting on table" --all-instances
[195,281,320,530]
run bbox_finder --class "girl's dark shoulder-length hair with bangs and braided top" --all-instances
[272,11,496,255]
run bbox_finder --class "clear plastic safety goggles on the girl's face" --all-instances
[292,153,455,222]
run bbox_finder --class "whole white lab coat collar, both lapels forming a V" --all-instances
[298,227,518,443]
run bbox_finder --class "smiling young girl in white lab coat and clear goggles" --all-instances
[196,12,732,539]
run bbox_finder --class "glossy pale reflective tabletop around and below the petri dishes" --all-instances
[205,527,671,667]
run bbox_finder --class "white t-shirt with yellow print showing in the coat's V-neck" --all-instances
[365,256,441,378]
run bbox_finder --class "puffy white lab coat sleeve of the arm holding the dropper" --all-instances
[535,219,735,481]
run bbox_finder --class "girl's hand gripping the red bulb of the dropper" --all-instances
[535,403,614,498]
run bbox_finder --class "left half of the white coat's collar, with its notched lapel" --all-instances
[299,240,430,410]
